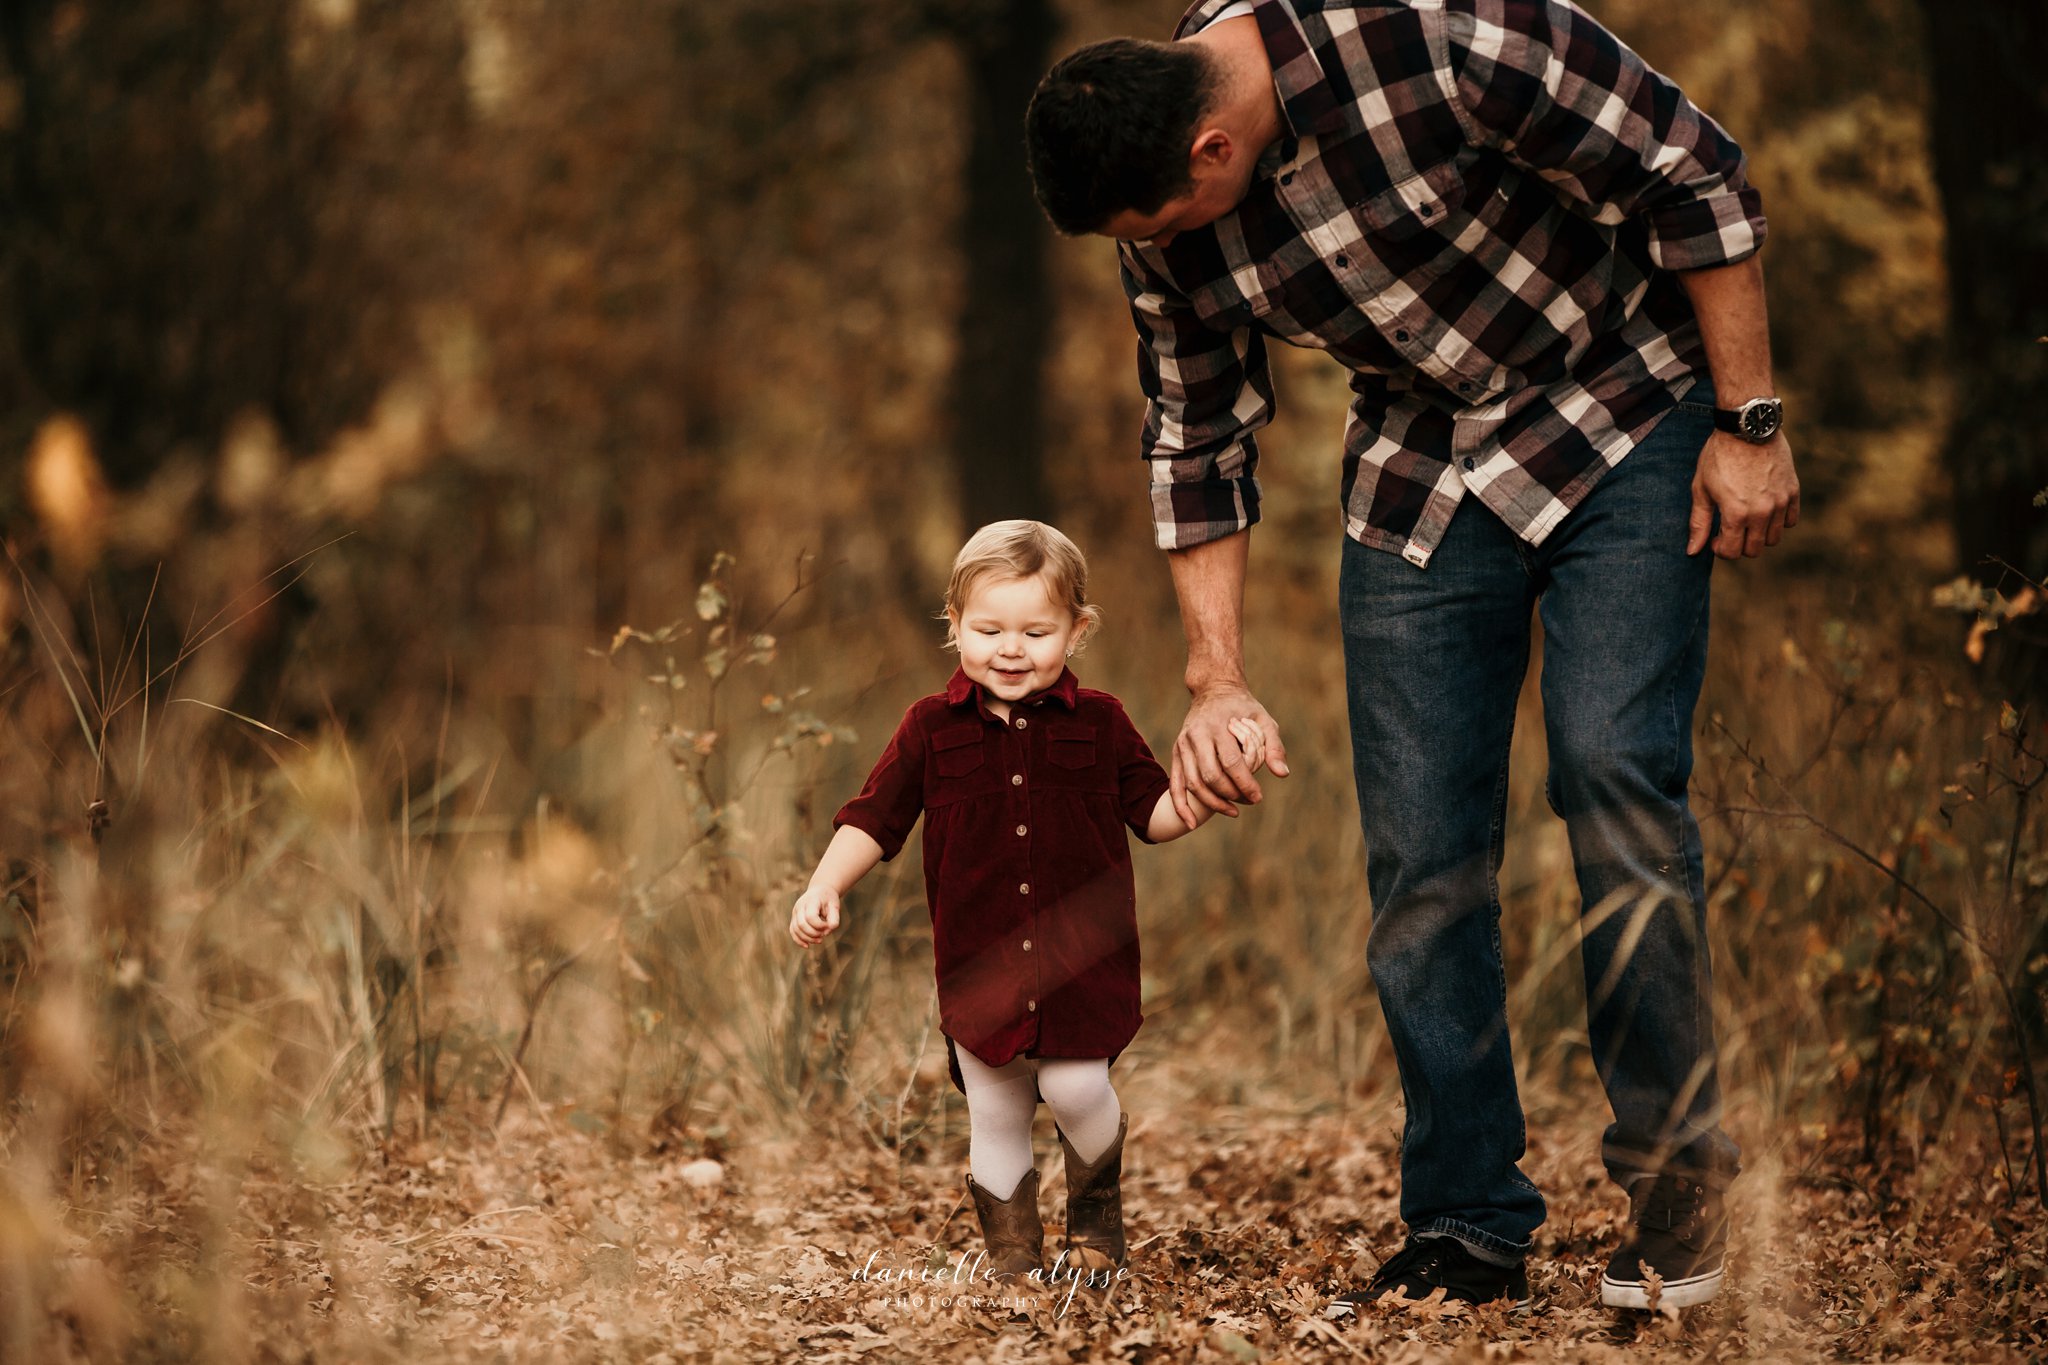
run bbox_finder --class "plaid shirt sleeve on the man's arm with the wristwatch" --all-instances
[1444,0,1765,270]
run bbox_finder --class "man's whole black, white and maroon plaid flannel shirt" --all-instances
[1118,0,1763,565]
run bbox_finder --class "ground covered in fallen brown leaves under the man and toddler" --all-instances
[41,1035,2048,1363]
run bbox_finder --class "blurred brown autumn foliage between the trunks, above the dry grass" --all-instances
[0,0,1974,716]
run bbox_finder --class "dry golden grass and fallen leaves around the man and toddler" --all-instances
[0,517,2048,1361]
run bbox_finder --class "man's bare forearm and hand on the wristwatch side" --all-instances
[1677,256,1798,559]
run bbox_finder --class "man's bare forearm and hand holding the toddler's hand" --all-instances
[1165,528,1288,829]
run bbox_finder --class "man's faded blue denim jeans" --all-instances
[1337,377,1737,1261]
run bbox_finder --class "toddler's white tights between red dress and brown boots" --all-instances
[952,1046,1122,1199]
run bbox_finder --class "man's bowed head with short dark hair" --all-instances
[1024,39,1257,246]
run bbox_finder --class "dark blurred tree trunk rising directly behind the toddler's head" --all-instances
[950,0,1053,528]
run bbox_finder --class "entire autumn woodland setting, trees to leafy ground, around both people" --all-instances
[0,0,2048,1359]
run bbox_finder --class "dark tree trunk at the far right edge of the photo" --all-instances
[1923,0,2048,700]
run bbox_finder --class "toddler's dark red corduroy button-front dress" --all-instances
[831,669,1169,1091]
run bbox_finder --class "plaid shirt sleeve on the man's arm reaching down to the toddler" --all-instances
[1116,241,1274,551]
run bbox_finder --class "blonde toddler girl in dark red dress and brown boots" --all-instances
[788,522,1264,1285]
